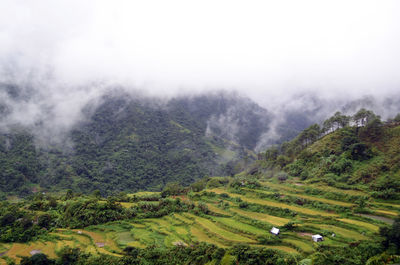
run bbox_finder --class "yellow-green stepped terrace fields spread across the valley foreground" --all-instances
[0,179,400,264]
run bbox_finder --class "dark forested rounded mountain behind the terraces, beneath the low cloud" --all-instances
[0,87,280,194]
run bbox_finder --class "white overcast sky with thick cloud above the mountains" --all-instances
[0,0,400,103]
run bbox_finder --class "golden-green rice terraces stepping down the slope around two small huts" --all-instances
[0,174,400,264]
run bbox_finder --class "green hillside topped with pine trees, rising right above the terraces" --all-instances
[263,109,400,199]
